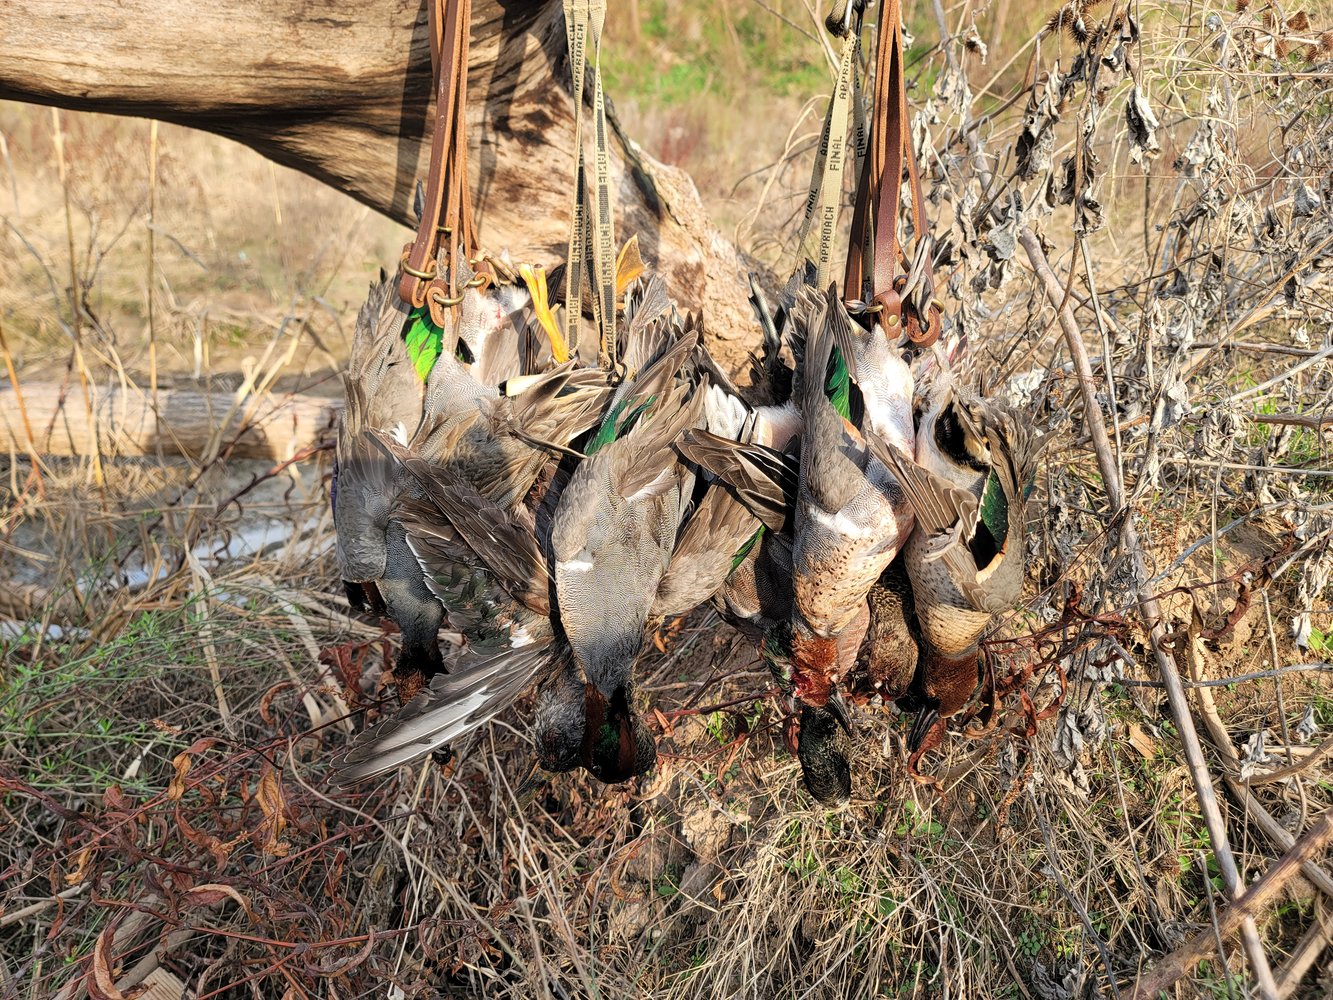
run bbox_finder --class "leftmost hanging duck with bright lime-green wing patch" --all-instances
[333,262,609,704]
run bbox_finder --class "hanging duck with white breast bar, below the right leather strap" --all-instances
[790,288,914,707]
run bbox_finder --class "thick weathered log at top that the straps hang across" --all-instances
[0,0,753,368]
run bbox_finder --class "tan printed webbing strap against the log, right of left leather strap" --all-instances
[564,0,616,367]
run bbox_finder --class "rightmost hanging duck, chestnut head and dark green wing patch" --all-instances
[886,373,1044,763]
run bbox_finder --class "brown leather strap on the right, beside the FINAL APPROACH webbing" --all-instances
[844,0,941,347]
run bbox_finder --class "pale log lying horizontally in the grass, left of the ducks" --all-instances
[0,383,343,461]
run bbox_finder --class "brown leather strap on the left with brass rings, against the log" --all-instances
[399,0,487,327]
